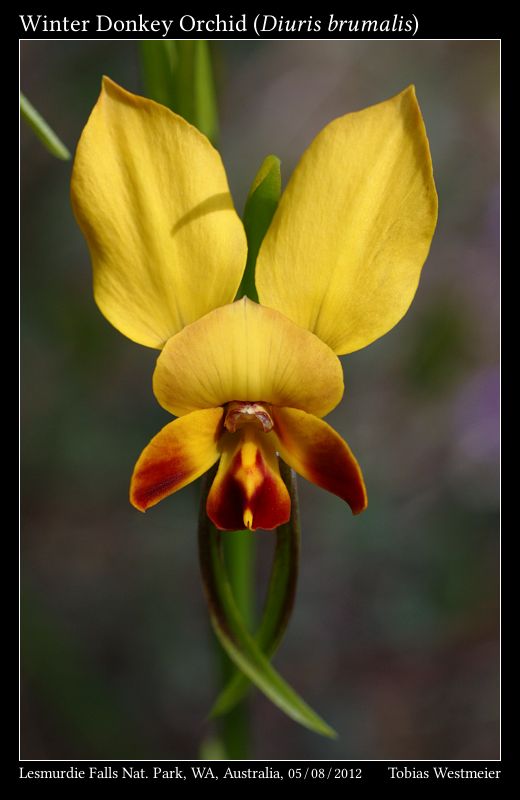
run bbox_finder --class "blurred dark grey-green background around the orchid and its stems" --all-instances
[21,41,499,759]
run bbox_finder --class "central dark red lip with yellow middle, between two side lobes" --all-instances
[206,425,291,531]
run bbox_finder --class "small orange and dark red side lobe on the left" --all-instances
[130,408,224,511]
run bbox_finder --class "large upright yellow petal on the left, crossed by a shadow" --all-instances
[72,78,247,347]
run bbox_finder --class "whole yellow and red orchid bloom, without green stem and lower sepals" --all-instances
[72,78,437,530]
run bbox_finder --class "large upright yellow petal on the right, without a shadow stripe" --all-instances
[256,86,437,354]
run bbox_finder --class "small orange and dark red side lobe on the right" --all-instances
[271,407,367,514]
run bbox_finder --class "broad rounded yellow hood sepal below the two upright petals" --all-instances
[153,298,343,417]
